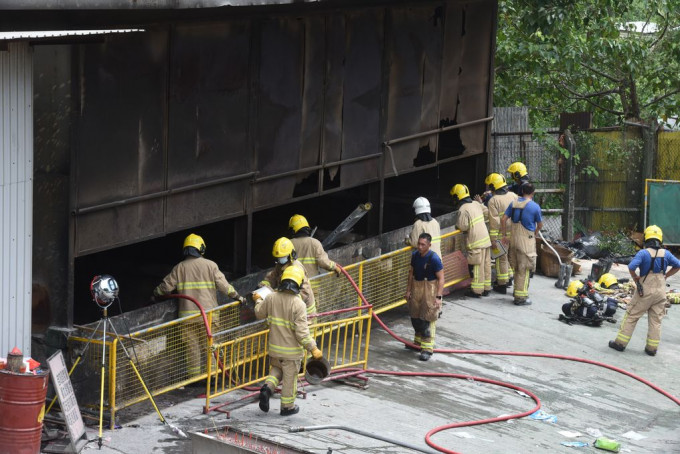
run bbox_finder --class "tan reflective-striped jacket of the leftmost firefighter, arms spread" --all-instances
[153,256,238,317]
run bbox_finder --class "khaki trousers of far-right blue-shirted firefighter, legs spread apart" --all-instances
[616,273,666,351]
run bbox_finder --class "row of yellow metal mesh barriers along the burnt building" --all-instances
[69,231,469,427]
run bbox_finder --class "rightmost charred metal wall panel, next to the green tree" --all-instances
[456,1,496,153]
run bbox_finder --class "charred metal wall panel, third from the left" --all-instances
[253,18,305,208]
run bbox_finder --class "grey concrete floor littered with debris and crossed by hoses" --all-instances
[65,261,680,454]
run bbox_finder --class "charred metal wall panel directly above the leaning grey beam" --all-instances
[340,9,385,187]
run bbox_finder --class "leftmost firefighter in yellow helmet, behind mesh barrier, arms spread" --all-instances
[153,233,245,377]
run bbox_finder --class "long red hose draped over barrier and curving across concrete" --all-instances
[340,267,680,454]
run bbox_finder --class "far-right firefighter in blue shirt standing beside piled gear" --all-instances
[609,225,680,356]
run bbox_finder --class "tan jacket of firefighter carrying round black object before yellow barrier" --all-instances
[255,290,316,360]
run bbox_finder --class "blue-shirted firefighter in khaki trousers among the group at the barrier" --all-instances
[501,183,543,306]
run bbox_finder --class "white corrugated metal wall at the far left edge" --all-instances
[0,43,33,356]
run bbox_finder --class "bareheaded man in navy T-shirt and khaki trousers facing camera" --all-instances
[406,233,444,361]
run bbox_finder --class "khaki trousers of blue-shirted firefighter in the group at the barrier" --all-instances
[508,222,536,301]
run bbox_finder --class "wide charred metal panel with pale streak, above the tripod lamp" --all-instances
[75,32,167,255]
